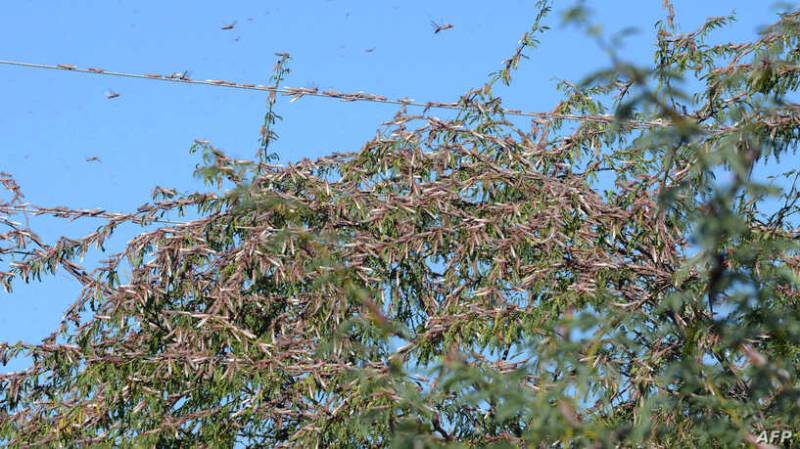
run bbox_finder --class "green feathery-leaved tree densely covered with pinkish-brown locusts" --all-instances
[0,2,800,448]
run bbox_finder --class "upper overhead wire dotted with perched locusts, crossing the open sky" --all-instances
[0,60,664,127]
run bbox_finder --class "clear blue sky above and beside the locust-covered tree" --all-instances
[0,0,788,370]
